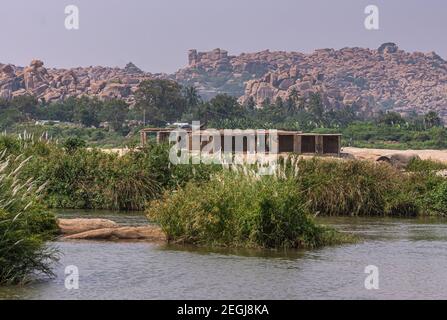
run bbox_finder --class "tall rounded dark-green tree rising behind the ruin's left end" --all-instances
[135,79,186,125]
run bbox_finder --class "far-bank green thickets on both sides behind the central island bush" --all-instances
[0,136,447,216]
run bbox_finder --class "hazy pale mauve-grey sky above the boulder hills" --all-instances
[0,0,447,72]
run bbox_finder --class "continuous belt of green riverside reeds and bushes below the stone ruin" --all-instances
[0,135,447,272]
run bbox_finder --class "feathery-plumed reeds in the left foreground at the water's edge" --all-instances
[0,152,57,285]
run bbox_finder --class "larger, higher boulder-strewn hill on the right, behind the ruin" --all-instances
[173,43,447,120]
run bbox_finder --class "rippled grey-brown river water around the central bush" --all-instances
[0,212,447,299]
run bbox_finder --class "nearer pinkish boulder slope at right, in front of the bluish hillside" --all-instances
[241,44,447,119]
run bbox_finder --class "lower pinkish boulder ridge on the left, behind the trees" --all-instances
[0,60,161,104]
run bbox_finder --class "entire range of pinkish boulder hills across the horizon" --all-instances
[0,43,447,120]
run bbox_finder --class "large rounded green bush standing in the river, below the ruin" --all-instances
[147,172,354,248]
